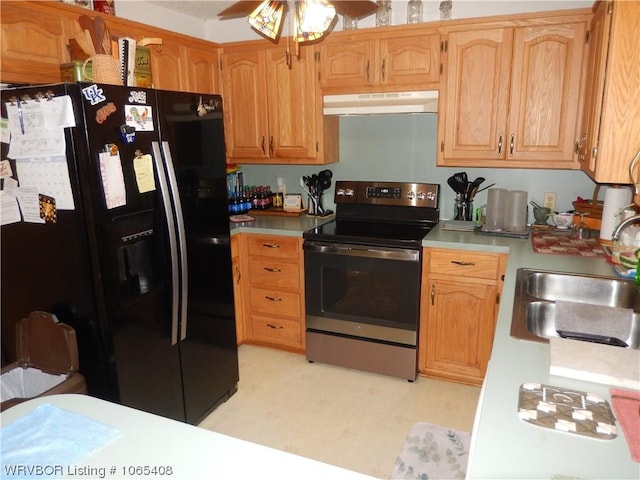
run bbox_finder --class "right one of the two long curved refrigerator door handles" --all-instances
[162,141,189,341]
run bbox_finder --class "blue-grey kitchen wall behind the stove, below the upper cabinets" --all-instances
[242,114,595,221]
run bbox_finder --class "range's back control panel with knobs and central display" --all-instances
[335,181,440,208]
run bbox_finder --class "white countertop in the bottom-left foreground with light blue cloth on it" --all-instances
[2,394,372,480]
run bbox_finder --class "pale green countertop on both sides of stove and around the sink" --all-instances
[233,217,640,480]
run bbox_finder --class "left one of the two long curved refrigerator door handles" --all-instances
[151,142,180,345]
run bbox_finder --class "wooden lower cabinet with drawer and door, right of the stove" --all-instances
[418,248,507,385]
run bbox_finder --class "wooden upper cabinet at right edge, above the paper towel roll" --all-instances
[580,2,640,183]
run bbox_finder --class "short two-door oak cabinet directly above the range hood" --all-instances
[319,31,440,93]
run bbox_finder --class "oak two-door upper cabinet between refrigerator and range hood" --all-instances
[222,42,338,164]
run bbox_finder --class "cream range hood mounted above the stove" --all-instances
[322,90,438,115]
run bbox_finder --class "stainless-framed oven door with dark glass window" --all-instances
[304,241,421,347]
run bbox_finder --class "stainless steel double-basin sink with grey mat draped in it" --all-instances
[511,268,640,349]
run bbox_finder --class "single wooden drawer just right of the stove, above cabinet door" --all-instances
[429,250,499,280]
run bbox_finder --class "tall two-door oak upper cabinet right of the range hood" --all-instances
[438,19,586,168]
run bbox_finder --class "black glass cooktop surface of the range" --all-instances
[303,219,434,248]
